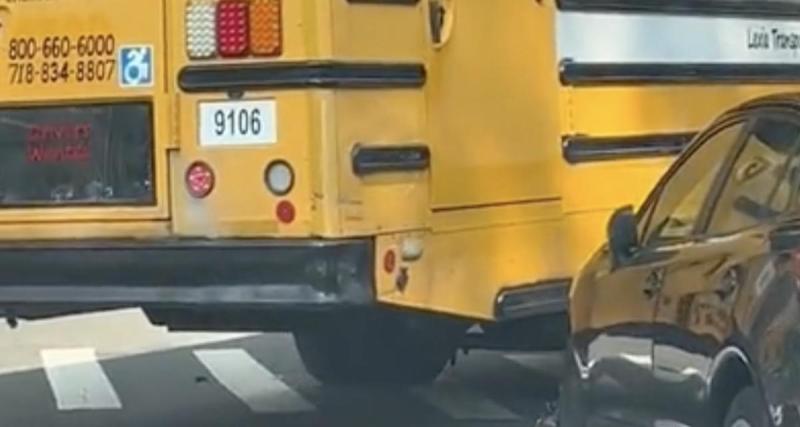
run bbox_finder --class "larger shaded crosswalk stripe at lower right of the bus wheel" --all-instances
[412,378,520,421]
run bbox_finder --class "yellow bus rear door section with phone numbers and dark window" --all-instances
[0,0,172,224]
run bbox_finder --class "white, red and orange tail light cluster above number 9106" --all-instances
[185,0,283,60]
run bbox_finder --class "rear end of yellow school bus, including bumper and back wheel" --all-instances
[0,0,446,388]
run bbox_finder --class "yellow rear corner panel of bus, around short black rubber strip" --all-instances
[315,0,430,236]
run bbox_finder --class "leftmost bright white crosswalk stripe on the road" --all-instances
[40,348,122,411]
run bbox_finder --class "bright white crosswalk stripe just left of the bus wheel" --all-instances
[194,349,315,413]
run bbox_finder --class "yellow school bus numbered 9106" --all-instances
[0,0,800,382]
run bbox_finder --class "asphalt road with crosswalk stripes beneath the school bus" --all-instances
[0,310,559,427]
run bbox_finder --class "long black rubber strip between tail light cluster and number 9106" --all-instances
[178,62,426,92]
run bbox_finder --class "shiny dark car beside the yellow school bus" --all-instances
[556,94,800,427]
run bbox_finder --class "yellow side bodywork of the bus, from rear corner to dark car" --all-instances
[376,1,800,320]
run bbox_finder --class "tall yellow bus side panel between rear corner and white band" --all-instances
[375,0,570,319]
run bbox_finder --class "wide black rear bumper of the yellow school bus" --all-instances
[0,240,375,317]
